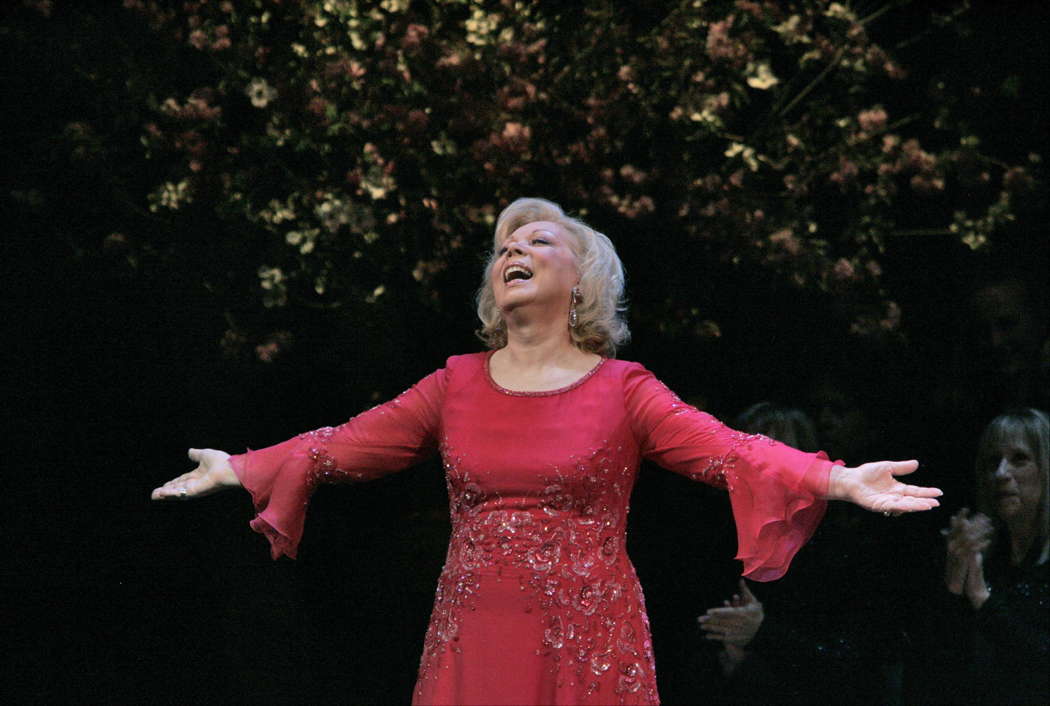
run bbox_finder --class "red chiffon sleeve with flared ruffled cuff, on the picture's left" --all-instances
[230,369,446,559]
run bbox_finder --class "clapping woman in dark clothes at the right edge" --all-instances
[917,409,1050,704]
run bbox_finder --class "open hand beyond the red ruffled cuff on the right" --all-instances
[827,461,943,515]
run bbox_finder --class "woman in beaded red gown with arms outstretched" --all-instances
[152,199,940,704]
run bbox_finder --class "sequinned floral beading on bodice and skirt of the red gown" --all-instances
[417,439,657,703]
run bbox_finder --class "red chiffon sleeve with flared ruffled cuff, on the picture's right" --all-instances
[625,365,833,581]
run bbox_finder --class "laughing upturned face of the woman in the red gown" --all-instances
[490,221,580,314]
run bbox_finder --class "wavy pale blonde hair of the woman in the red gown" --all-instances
[478,199,631,357]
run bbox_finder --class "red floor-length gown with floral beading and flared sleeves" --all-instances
[231,353,831,705]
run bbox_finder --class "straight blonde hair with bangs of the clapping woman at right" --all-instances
[977,409,1050,563]
